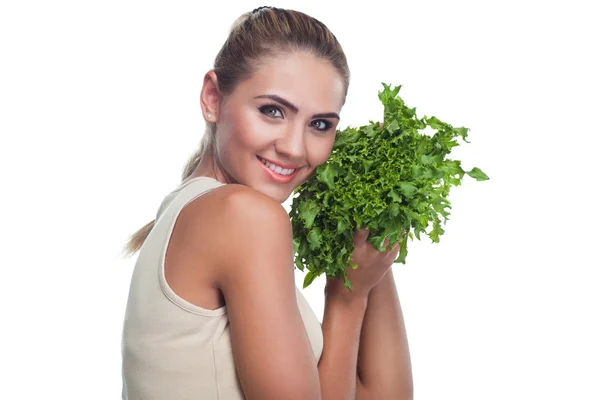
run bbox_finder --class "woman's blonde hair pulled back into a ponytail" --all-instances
[124,7,350,255]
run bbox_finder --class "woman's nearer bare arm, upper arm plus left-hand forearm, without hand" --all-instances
[213,185,367,400]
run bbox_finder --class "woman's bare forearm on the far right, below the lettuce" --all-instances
[357,268,413,400]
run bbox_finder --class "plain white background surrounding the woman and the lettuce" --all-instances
[0,0,600,400]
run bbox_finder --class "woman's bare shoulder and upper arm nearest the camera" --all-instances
[204,188,321,400]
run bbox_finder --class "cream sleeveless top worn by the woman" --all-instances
[121,177,323,400]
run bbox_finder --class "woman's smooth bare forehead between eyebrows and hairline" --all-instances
[236,53,344,114]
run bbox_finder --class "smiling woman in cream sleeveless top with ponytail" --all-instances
[122,7,412,400]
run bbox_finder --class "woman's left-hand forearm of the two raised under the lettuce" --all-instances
[318,294,367,400]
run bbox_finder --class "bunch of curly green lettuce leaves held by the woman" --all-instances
[289,83,489,291]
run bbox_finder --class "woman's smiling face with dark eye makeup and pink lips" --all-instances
[202,53,344,203]
